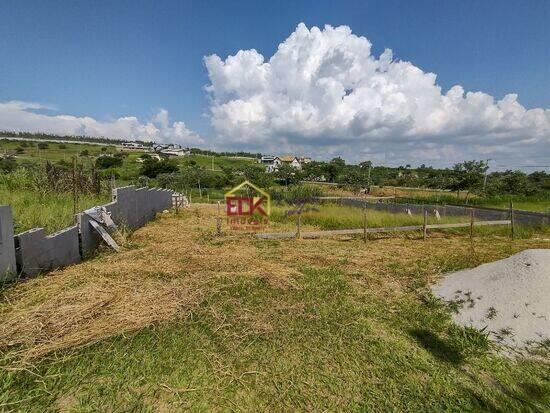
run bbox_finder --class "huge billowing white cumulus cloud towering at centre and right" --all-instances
[204,24,550,164]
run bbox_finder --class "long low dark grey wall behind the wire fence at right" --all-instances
[339,198,550,225]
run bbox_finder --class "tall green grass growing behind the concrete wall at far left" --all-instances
[0,188,109,233]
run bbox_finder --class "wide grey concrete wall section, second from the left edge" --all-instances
[15,225,81,276]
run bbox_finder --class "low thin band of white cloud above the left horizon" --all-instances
[0,101,204,146]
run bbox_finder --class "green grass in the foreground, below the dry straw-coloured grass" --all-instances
[0,263,550,412]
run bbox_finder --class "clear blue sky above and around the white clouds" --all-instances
[0,1,550,166]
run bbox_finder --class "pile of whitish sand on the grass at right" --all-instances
[432,249,550,348]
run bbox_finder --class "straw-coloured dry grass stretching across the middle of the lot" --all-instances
[0,205,547,361]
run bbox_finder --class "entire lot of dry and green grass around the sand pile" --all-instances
[0,205,550,412]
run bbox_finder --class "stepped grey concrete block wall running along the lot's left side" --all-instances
[0,186,173,281]
